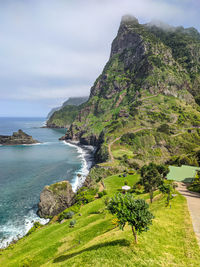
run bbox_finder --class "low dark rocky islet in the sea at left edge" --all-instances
[0,130,39,146]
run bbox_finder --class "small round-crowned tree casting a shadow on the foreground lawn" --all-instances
[107,193,154,243]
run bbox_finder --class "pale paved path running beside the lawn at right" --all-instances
[177,182,200,246]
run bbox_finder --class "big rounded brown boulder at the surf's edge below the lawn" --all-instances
[37,181,75,218]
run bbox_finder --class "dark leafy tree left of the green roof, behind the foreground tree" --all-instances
[140,163,169,203]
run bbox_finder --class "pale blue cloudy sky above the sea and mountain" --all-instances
[0,0,200,117]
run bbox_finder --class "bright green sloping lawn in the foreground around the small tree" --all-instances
[0,175,200,267]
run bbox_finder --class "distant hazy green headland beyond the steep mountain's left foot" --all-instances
[47,97,88,128]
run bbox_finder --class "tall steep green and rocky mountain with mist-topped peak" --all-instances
[65,16,200,165]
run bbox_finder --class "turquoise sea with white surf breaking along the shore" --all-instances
[0,118,92,247]
